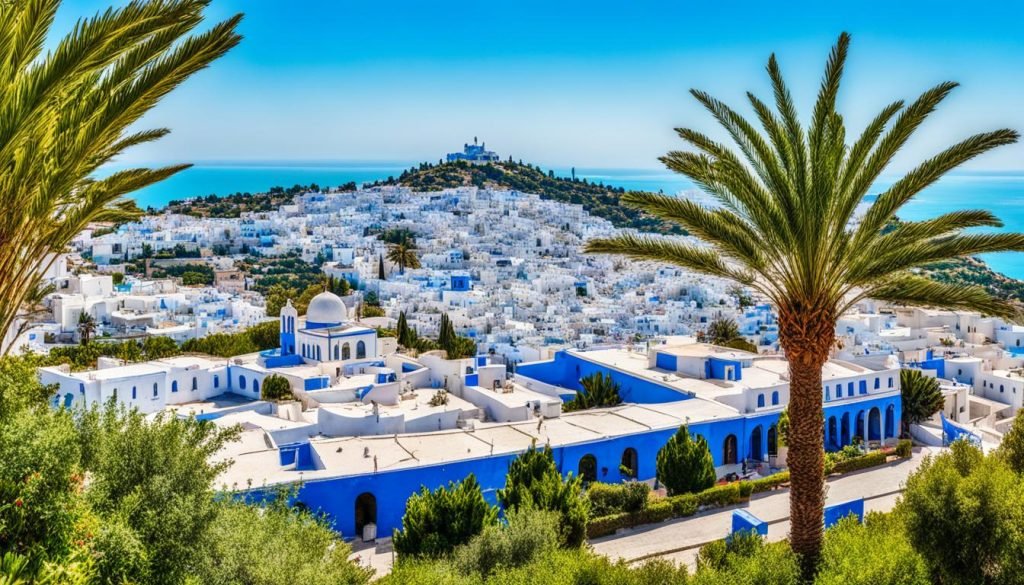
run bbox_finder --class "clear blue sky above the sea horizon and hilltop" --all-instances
[56,0,1024,170]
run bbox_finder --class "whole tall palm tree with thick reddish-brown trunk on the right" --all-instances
[587,33,1024,578]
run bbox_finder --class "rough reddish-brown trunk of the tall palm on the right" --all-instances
[779,309,836,583]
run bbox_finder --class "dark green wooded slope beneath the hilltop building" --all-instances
[366,161,683,234]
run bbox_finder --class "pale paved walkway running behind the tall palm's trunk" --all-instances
[591,447,933,567]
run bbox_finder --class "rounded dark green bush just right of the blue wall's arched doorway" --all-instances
[394,473,498,557]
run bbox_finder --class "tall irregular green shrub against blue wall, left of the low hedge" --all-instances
[498,446,589,547]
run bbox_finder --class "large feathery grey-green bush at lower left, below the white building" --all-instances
[77,402,239,584]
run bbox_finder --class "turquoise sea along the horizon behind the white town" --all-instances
[121,161,1024,280]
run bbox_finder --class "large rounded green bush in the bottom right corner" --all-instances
[897,441,1024,585]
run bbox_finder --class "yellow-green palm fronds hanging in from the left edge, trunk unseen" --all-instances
[0,0,241,353]
